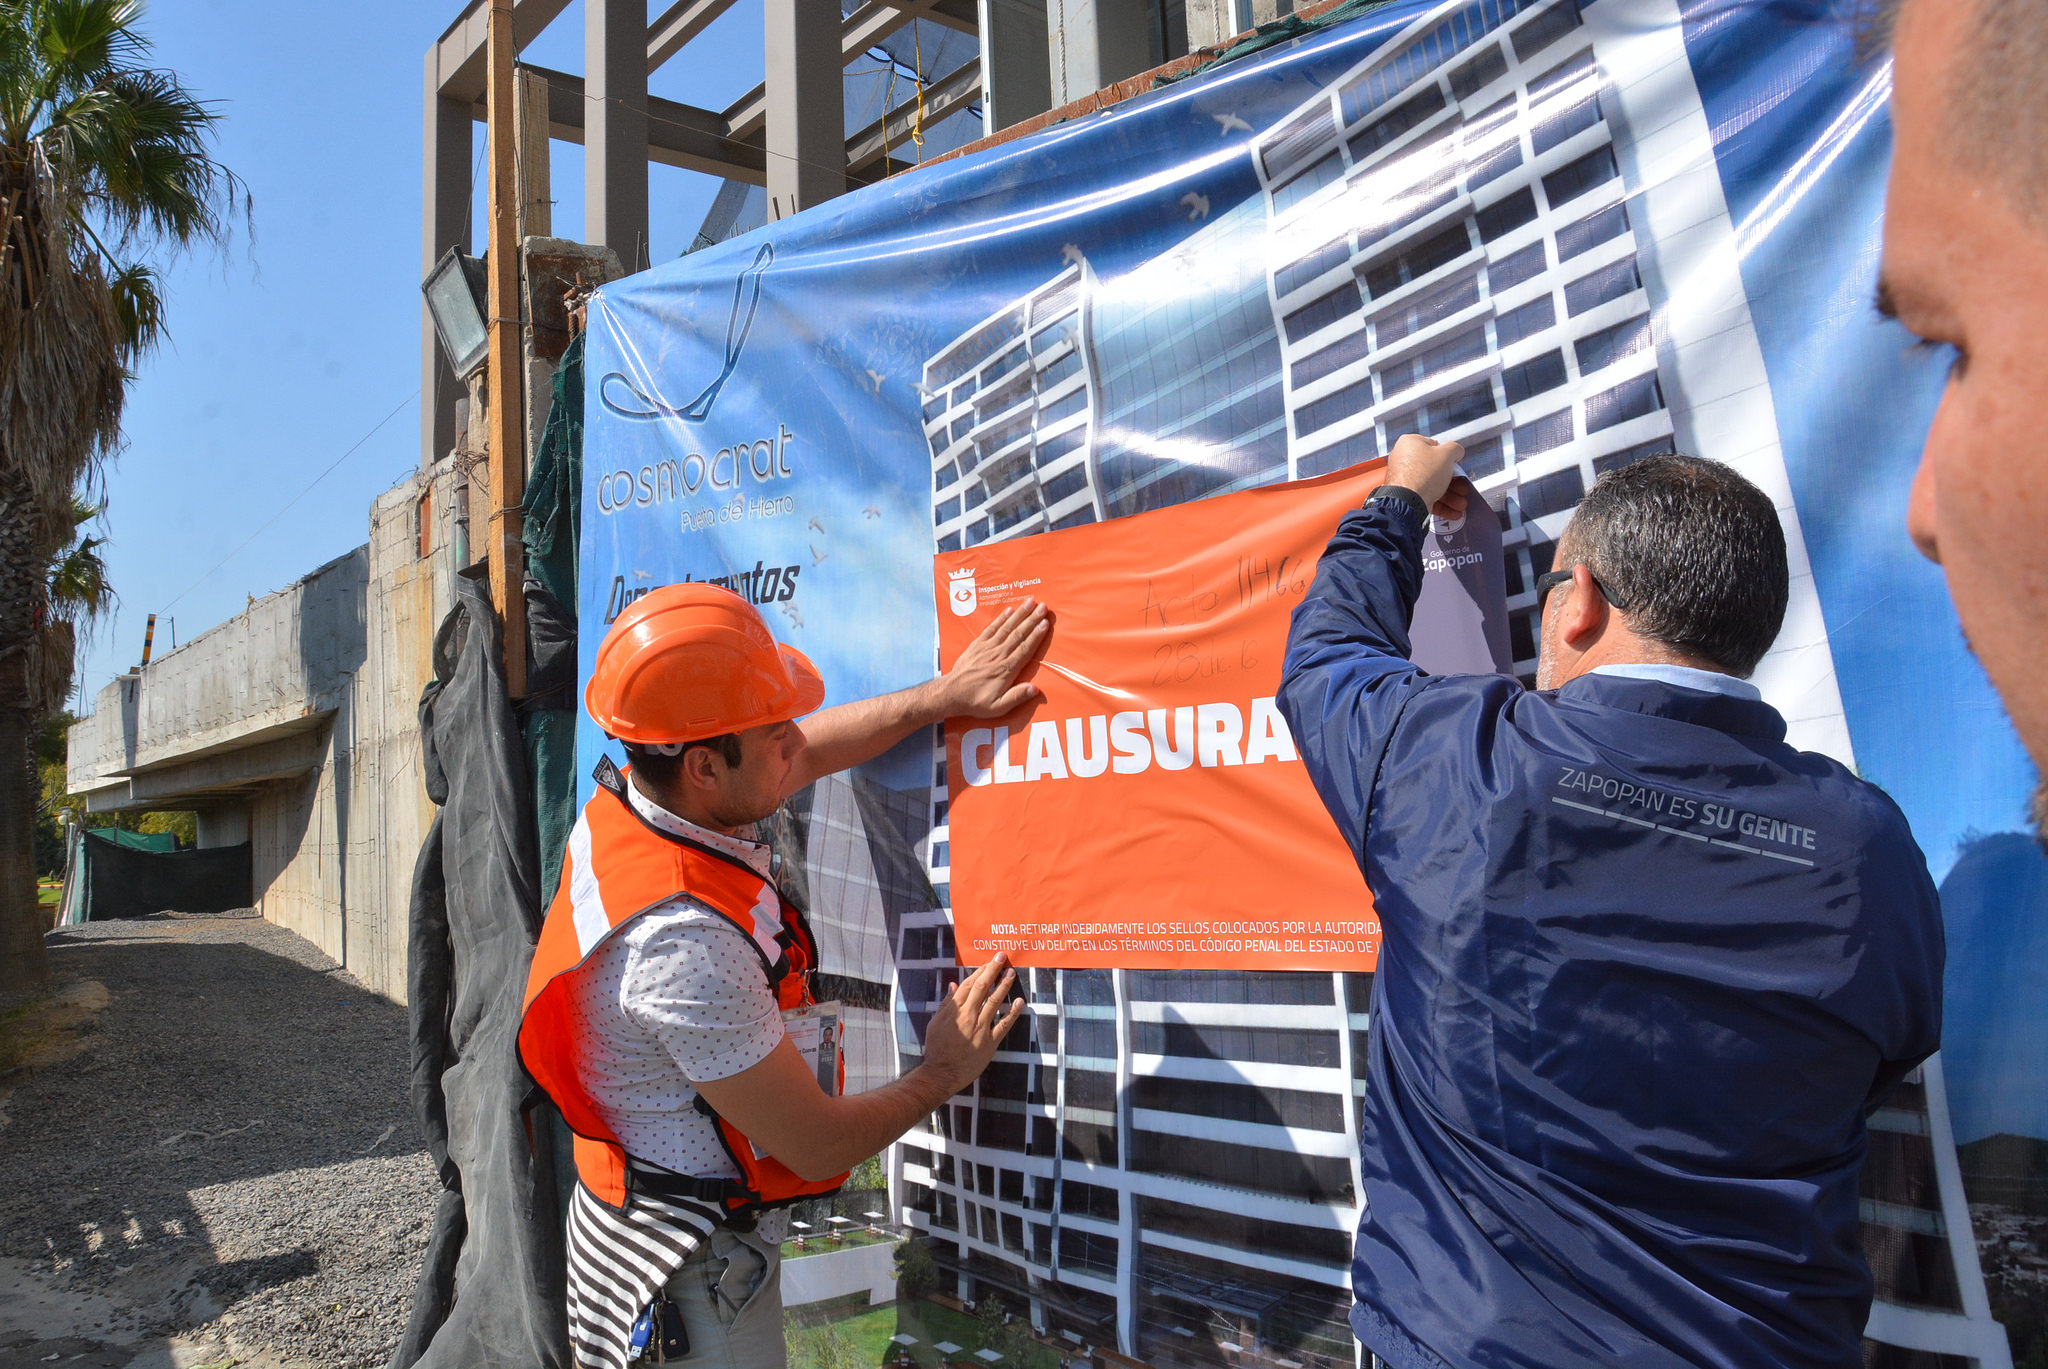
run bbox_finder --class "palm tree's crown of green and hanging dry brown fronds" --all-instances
[0,0,250,566]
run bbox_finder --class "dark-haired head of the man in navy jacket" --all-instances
[1536,457,1790,689]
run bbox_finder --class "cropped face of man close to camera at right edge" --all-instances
[1878,0,2048,824]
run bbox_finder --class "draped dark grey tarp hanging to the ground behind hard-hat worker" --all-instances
[391,574,569,1369]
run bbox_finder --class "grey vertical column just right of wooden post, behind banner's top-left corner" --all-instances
[584,0,653,273]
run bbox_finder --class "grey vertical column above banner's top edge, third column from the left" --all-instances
[761,0,846,221]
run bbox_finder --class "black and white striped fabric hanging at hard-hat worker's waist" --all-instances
[567,1185,719,1369]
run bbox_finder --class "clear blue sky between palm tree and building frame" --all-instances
[74,0,762,711]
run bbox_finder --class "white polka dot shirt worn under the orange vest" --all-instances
[573,787,782,1178]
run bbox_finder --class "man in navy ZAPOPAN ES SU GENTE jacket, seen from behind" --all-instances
[1280,437,1942,1369]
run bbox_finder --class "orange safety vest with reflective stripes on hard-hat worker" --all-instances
[518,758,846,1217]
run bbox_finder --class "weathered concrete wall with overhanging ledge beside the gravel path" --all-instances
[68,461,459,1000]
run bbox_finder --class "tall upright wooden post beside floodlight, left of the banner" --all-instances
[483,0,526,699]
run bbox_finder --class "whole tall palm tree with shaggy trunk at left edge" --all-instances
[0,0,248,992]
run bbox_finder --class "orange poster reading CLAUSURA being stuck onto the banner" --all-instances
[934,465,1382,969]
